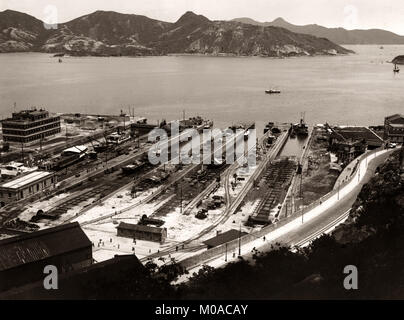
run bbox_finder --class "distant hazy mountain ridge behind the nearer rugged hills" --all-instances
[232,18,404,45]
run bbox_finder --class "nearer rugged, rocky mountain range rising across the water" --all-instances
[0,10,352,57]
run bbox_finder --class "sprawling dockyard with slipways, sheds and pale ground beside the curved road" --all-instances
[0,109,388,263]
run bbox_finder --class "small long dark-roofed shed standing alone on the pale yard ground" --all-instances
[117,222,167,243]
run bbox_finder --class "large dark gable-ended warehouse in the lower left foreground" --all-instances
[0,222,93,291]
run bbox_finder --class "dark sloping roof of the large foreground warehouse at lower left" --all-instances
[0,222,91,271]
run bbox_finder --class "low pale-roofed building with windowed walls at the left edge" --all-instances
[0,171,56,206]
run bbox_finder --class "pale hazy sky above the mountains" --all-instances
[0,0,404,35]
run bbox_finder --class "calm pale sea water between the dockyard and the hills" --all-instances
[0,46,404,129]
